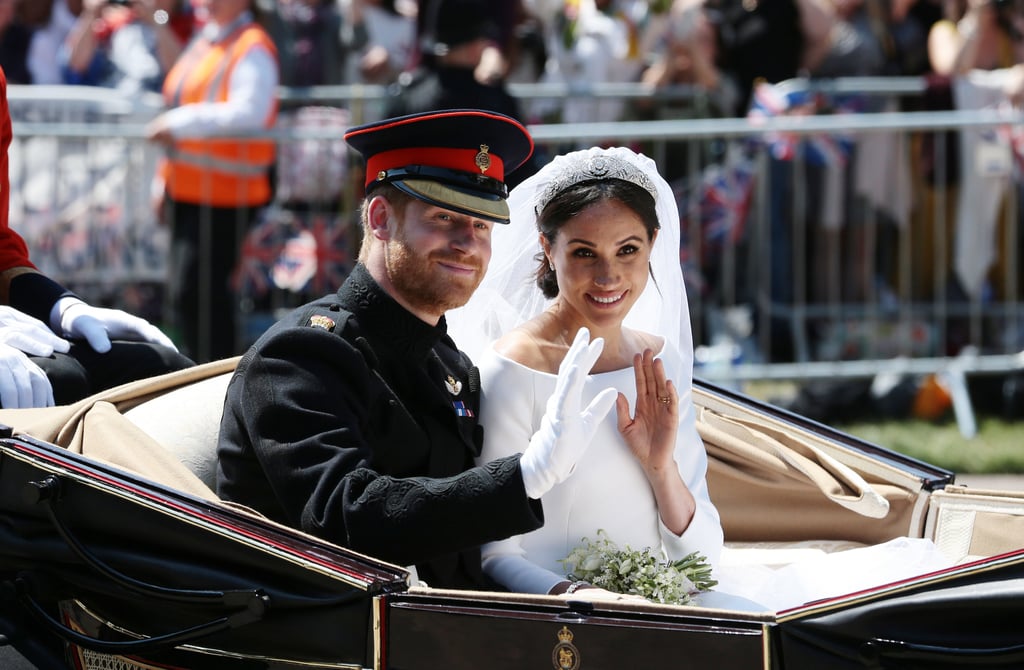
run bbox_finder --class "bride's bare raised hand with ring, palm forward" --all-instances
[615,349,679,477]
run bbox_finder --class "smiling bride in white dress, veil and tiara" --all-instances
[450,149,722,594]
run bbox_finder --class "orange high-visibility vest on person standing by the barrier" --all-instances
[161,23,278,207]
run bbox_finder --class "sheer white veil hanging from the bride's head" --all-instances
[445,146,693,372]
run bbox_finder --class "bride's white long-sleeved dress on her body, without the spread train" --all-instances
[478,348,722,593]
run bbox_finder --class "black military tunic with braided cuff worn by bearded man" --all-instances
[217,264,543,588]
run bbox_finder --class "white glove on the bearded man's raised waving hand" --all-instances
[519,328,618,499]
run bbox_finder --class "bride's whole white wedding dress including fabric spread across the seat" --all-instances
[479,342,953,612]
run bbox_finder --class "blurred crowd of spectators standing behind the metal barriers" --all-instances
[0,0,1024,370]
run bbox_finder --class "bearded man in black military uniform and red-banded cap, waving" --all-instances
[217,110,614,588]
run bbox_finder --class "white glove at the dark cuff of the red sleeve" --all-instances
[53,298,177,353]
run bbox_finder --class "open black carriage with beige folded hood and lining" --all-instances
[0,361,1024,670]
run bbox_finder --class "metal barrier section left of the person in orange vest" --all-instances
[7,85,167,323]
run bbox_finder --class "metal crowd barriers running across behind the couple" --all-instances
[9,78,1024,428]
